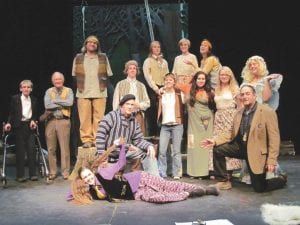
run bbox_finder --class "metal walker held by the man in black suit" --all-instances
[0,123,50,188]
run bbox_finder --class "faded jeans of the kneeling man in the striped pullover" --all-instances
[126,149,159,176]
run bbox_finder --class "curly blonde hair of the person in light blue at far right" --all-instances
[241,55,269,83]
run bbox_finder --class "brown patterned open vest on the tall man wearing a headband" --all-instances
[75,53,107,92]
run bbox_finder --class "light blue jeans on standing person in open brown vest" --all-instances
[158,124,183,177]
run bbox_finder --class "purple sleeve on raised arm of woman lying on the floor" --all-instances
[98,145,126,180]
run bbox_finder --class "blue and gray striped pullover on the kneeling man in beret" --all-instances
[96,109,152,157]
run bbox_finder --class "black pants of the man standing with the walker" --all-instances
[14,122,36,178]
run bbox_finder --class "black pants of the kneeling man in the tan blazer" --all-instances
[213,140,285,192]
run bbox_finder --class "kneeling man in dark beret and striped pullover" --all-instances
[96,94,159,176]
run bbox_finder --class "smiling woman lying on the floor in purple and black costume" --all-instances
[68,139,219,204]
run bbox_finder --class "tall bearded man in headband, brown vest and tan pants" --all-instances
[72,35,113,148]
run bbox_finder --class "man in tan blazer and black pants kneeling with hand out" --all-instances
[201,85,287,192]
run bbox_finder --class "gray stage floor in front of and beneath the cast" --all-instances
[0,155,300,225]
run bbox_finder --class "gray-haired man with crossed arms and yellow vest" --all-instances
[44,72,74,180]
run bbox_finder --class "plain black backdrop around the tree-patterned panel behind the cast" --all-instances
[0,0,300,154]
